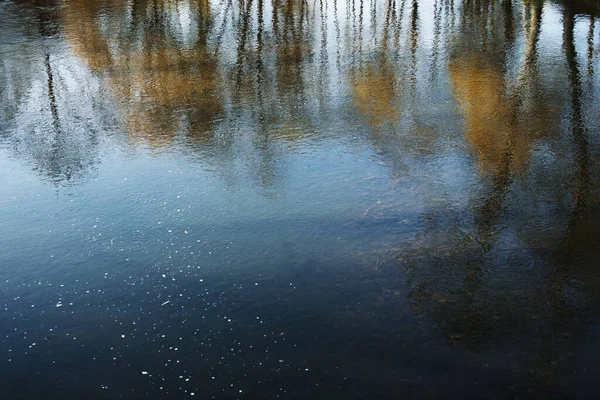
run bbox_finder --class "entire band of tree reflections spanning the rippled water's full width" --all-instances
[0,0,600,394]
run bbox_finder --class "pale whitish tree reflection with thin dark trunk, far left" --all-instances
[0,0,120,185]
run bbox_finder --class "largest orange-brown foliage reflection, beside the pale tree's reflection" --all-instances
[64,0,222,147]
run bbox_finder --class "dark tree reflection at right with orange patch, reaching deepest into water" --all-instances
[392,0,600,389]
